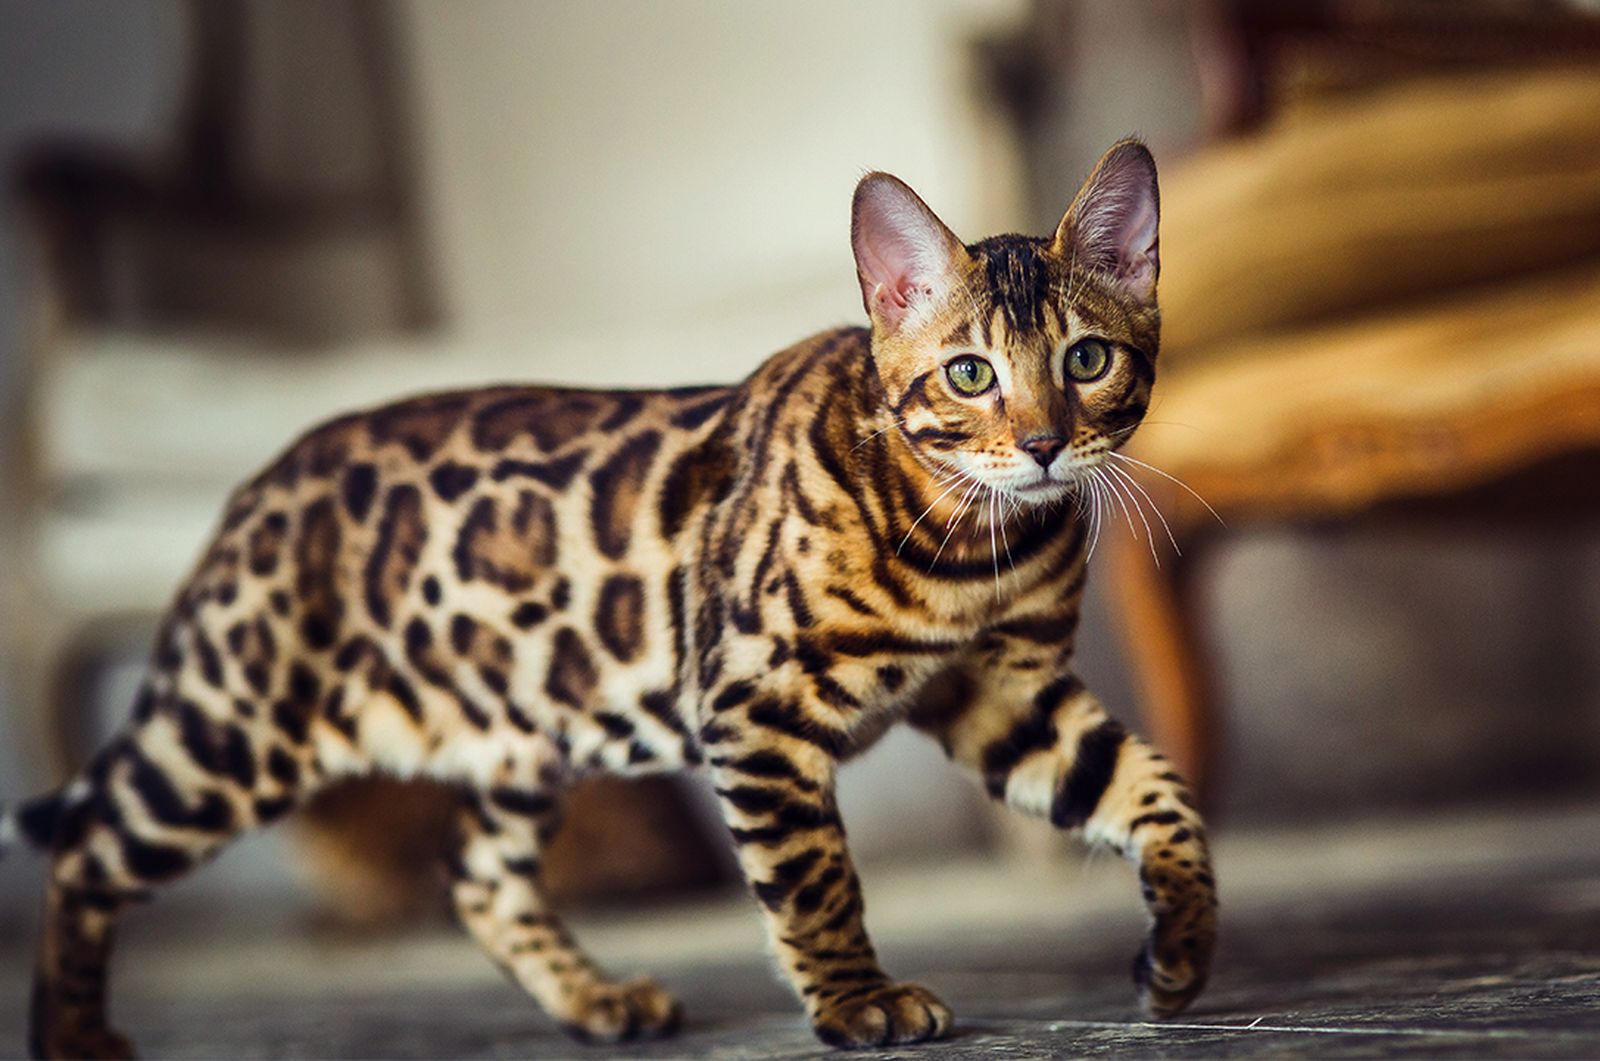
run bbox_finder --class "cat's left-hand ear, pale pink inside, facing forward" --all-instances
[850,173,968,331]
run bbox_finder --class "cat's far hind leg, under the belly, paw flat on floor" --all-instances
[450,787,682,1042]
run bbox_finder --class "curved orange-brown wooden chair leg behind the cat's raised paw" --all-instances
[1109,539,1218,805]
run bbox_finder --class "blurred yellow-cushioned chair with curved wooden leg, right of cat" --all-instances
[1112,60,1600,787]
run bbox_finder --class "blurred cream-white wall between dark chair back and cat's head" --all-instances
[408,0,1021,382]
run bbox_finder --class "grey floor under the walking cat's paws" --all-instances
[0,803,1600,1058]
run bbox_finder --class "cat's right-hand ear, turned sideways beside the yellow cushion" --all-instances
[1056,139,1162,304]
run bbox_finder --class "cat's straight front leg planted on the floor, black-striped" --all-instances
[701,682,950,1047]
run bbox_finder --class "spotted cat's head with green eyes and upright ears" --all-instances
[851,139,1160,502]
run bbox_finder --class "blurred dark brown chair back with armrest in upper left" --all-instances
[18,0,440,342]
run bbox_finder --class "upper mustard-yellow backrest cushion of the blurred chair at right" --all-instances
[1162,67,1600,356]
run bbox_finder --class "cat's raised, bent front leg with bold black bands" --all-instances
[912,659,1216,1016]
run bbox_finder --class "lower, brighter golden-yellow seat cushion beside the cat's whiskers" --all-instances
[1128,262,1600,522]
